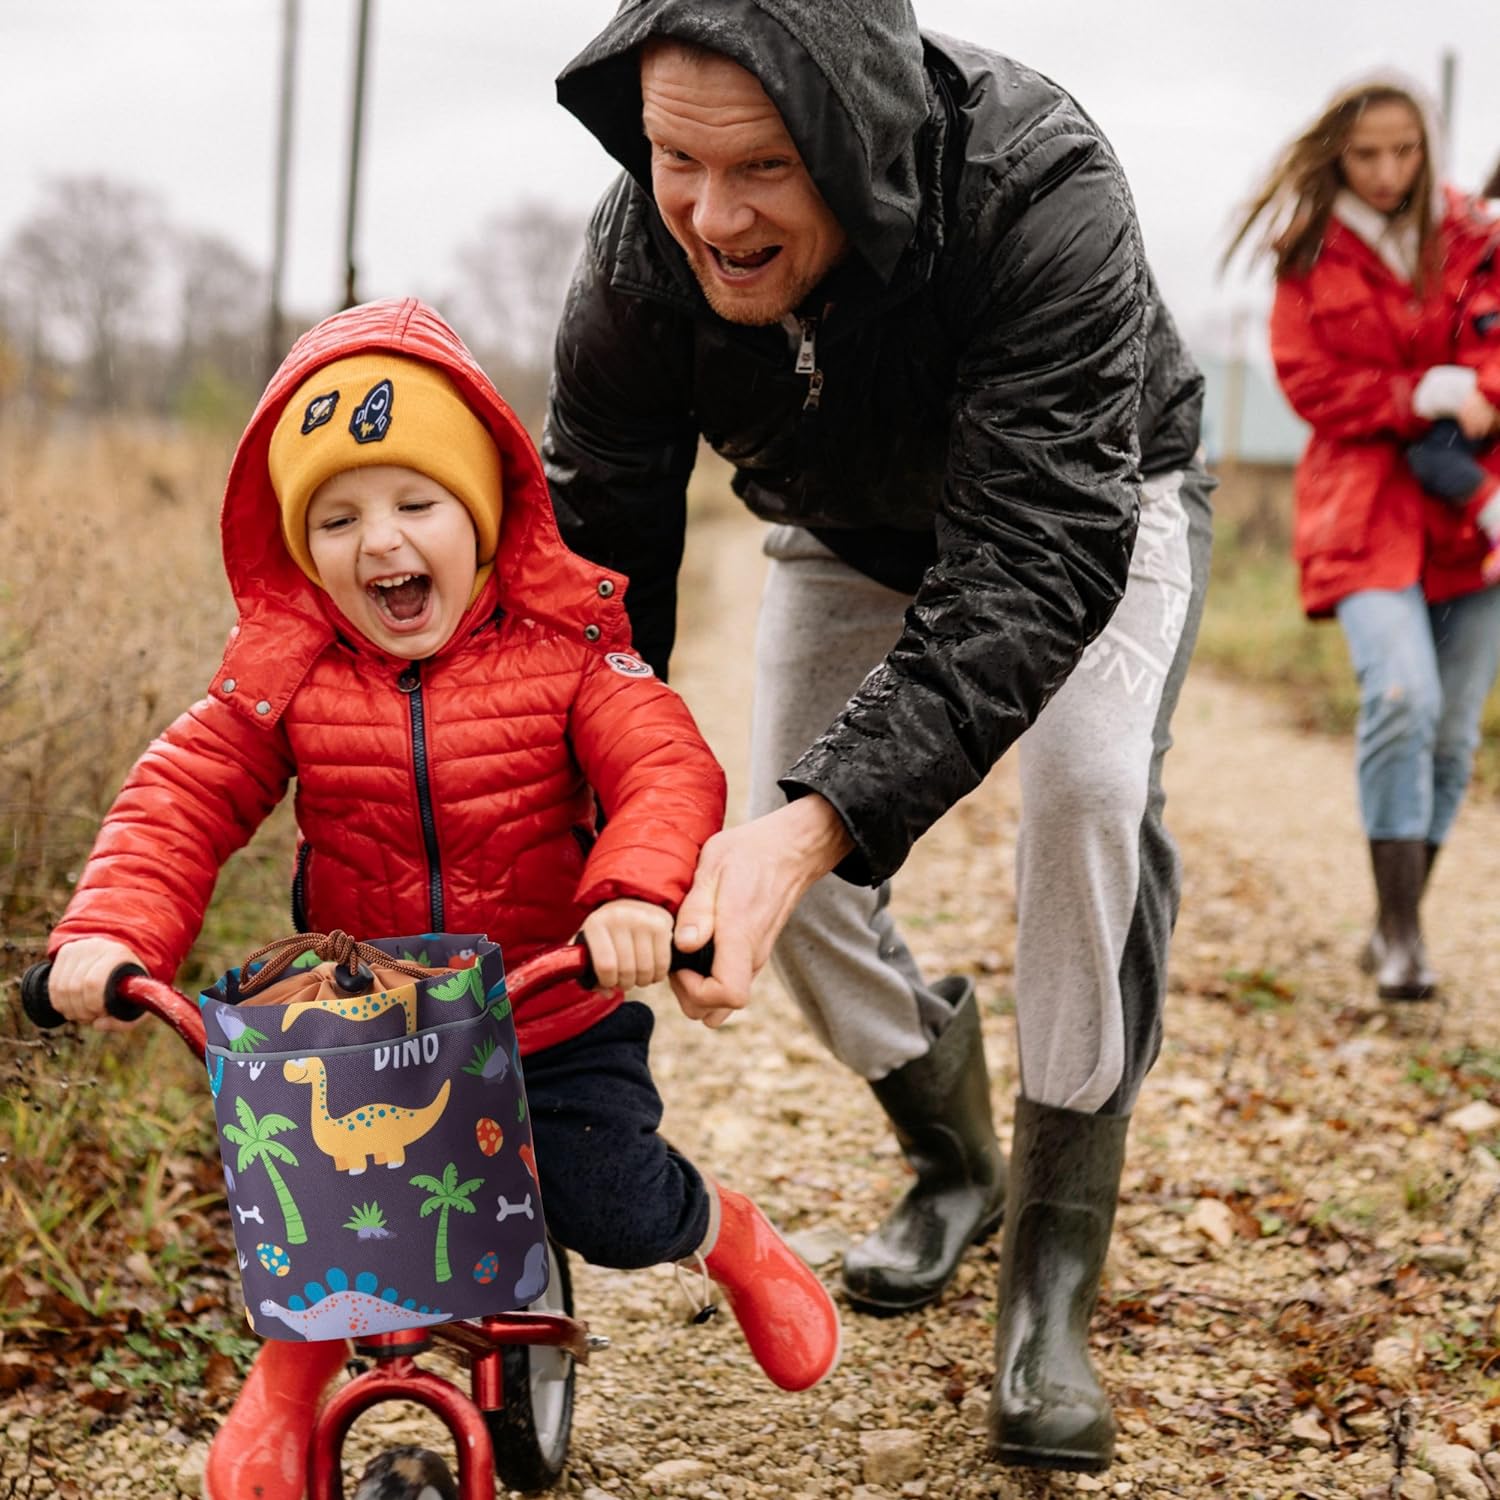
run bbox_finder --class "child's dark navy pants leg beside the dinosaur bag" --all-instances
[524,1001,708,1269]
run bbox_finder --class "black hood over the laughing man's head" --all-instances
[557,0,930,282]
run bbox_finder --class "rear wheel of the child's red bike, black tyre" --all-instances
[485,1239,576,1493]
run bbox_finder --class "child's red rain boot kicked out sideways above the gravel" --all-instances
[699,1188,840,1391]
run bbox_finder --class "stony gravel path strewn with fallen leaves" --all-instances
[0,498,1500,1500]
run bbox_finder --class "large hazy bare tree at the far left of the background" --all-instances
[8,177,161,407]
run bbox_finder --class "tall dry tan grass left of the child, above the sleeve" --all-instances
[0,420,298,968]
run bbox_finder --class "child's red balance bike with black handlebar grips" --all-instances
[21,945,713,1500]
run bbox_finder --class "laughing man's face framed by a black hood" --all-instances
[641,47,849,324]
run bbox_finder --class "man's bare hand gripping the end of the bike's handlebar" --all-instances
[672,794,854,1026]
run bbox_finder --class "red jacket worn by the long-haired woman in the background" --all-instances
[1271,195,1500,618]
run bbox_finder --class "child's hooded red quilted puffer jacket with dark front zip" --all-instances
[51,300,725,1053]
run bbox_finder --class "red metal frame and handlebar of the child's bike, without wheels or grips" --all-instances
[117,945,599,1500]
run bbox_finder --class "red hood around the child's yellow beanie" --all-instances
[213,297,630,725]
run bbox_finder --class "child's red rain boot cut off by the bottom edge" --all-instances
[203,1338,350,1500]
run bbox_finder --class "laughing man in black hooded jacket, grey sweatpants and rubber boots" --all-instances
[543,0,1209,1469]
